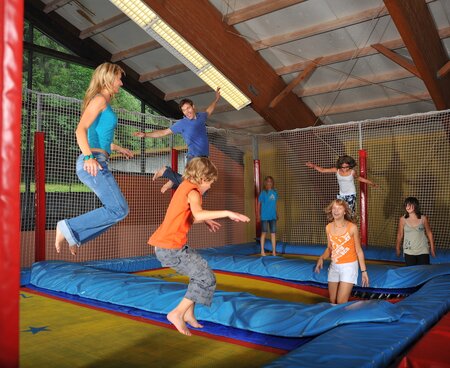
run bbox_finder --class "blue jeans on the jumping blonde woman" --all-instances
[57,152,128,246]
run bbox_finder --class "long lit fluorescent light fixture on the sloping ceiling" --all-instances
[110,0,251,110]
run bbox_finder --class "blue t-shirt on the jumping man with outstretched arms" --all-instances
[170,112,209,157]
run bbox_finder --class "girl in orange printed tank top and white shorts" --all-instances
[315,199,369,304]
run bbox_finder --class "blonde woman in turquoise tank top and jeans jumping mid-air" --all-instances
[55,63,133,255]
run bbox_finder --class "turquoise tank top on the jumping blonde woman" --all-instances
[88,104,117,154]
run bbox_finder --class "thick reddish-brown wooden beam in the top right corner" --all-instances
[384,0,450,110]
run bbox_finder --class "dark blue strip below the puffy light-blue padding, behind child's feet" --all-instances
[23,285,311,351]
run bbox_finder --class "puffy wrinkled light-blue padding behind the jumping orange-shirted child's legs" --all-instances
[31,262,403,337]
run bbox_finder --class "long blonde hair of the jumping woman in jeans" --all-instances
[81,63,125,112]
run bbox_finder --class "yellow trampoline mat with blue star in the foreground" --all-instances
[20,289,279,368]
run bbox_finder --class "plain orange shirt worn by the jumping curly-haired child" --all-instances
[148,180,201,249]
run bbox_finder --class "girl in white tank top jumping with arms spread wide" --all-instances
[306,155,378,214]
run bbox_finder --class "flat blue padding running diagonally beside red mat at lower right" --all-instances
[265,275,450,368]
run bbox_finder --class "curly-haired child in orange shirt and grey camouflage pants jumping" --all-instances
[148,157,250,336]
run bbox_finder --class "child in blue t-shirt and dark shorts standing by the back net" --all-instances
[258,176,278,256]
